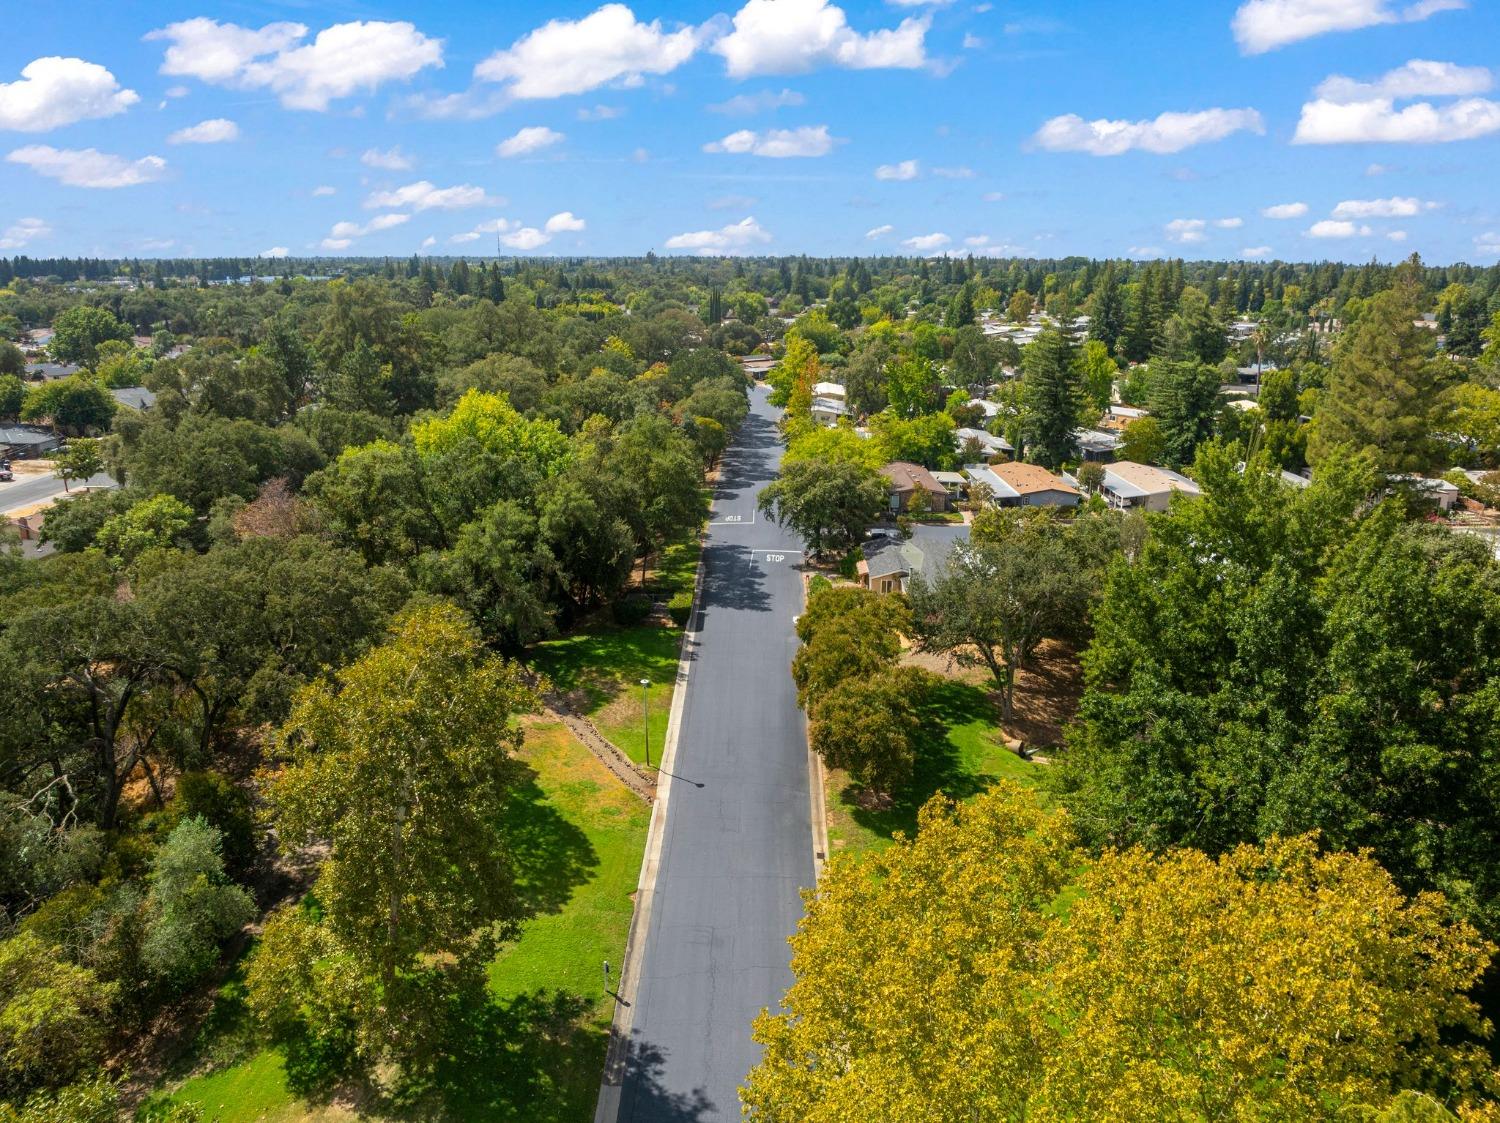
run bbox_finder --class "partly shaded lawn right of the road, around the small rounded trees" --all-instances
[828,681,1044,853]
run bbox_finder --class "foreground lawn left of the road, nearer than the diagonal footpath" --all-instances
[141,723,650,1123]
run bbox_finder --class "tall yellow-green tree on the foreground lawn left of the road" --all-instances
[269,604,536,1051]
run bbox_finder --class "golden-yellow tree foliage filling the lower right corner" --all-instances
[741,784,1493,1123]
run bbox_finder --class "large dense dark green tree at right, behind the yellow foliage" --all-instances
[1058,442,1500,933]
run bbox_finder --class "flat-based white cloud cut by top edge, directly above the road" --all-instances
[713,0,932,78]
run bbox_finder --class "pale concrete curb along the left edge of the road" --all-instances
[594,521,713,1123]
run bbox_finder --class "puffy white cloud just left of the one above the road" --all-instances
[474,3,702,99]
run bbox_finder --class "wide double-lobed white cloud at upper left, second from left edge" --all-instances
[146,16,443,109]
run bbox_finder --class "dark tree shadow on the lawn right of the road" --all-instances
[839,679,999,838]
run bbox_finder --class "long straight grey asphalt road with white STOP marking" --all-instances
[618,388,815,1123]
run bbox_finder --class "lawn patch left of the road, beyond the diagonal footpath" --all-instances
[530,620,684,765]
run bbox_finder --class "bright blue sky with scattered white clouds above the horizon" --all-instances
[0,0,1500,264]
